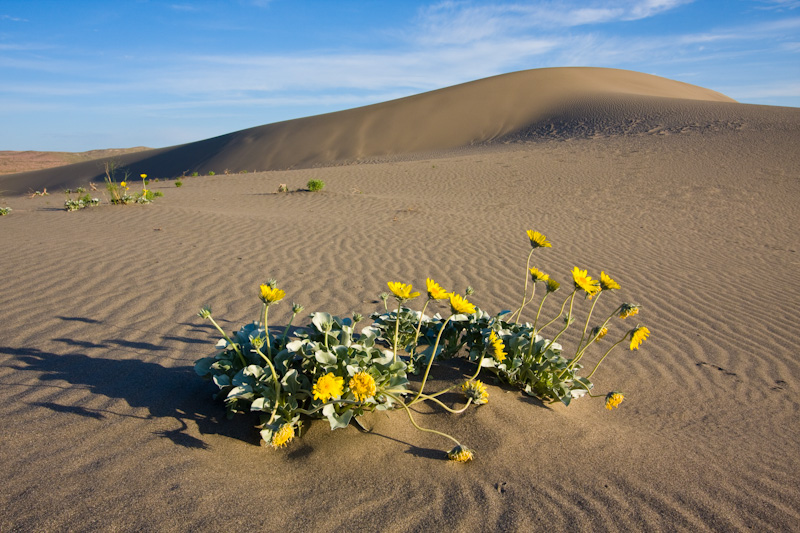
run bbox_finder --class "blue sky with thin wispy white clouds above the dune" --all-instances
[0,0,800,151]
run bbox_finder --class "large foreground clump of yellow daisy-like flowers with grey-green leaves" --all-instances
[195,231,650,462]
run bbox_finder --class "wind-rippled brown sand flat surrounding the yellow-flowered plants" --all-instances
[0,68,800,532]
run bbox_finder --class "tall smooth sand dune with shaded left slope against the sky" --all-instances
[0,68,733,194]
